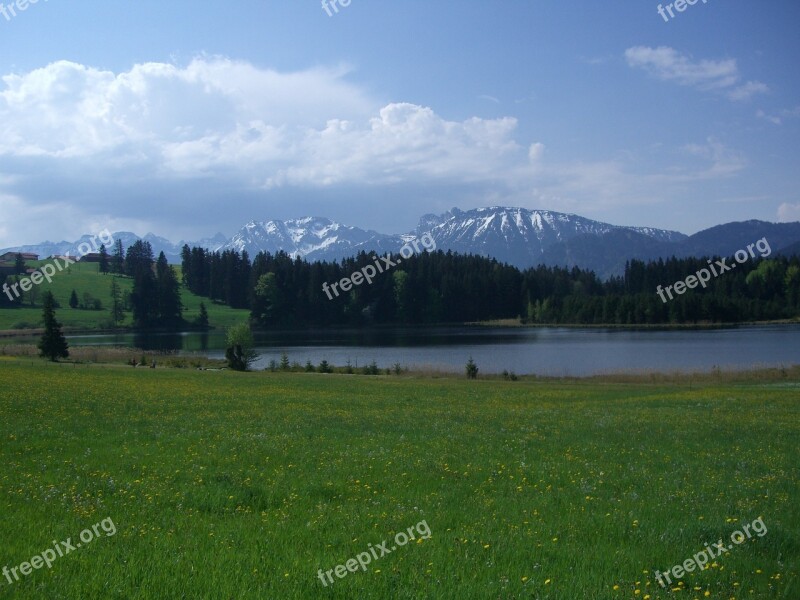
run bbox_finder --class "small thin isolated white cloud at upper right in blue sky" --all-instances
[625,46,769,101]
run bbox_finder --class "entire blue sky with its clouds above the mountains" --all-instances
[0,0,800,247]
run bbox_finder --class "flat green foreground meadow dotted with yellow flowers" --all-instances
[0,364,800,600]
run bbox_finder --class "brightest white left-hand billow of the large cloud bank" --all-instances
[0,58,375,157]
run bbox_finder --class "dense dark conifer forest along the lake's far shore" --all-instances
[182,246,800,328]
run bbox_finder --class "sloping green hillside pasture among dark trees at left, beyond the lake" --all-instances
[0,261,250,331]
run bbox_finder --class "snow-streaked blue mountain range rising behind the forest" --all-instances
[0,207,800,278]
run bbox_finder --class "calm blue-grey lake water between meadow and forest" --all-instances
[59,325,800,376]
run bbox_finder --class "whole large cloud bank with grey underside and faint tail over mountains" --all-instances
[0,57,768,246]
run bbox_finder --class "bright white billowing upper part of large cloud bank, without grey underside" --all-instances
[0,58,524,187]
